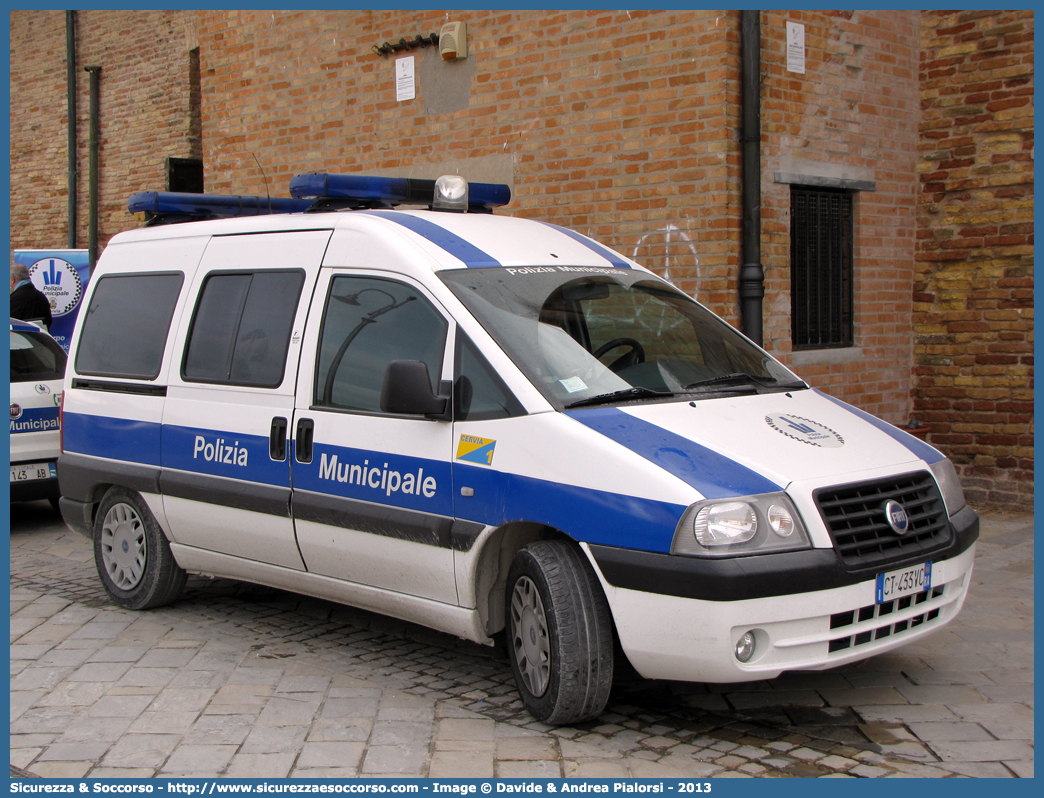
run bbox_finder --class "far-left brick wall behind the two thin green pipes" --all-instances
[10,10,200,252]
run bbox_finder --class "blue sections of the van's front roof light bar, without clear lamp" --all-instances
[290,172,512,211]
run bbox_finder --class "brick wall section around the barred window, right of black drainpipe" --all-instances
[761,10,920,423]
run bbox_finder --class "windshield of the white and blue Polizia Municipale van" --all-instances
[438,266,807,408]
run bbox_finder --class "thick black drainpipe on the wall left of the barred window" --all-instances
[739,10,765,346]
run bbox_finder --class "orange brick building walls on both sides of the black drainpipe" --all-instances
[199,10,919,422]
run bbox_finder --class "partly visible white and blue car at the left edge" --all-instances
[10,319,66,509]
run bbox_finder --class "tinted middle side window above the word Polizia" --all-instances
[182,269,305,388]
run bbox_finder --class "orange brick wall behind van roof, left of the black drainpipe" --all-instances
[192,10,738,318]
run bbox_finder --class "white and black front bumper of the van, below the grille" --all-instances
[585,510,978,683]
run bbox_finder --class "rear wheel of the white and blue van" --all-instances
[94,488,187,610]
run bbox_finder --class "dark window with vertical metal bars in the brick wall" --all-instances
[790,186,853,350]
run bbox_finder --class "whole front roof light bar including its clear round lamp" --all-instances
[290,172,512,213]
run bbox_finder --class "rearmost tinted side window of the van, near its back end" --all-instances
[76,272,185,379]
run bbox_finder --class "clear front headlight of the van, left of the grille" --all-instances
[670,493,811,557]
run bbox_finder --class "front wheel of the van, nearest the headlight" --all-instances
[504,540,613,725]
